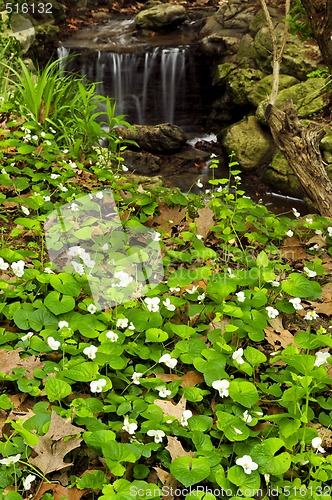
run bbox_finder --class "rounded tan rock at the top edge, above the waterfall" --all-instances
[135,3,187,30]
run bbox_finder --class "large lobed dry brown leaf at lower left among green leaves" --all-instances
[30,411,84,474]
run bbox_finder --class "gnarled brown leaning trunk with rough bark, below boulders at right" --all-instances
[265,101,332,217]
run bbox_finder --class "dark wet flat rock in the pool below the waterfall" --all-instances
[115,123,187,153]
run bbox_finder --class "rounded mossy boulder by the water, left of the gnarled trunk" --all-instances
[218,116,275,171]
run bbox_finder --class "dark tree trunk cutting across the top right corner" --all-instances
[301,0,332,75]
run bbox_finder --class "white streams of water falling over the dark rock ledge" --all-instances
[58,45,208,131]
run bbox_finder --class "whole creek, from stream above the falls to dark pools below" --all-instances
[58,15,305,213]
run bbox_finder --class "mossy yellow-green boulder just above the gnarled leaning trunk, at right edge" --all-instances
[256,78,328,123]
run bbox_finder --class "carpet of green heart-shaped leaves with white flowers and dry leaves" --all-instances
[0,57,332,500]
